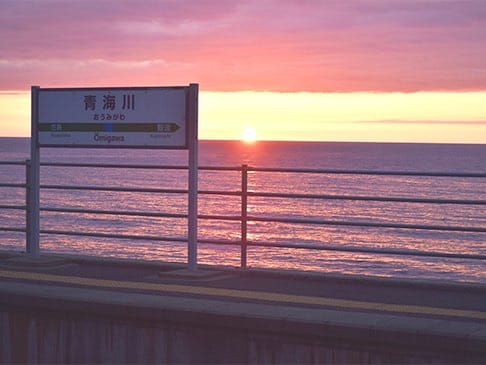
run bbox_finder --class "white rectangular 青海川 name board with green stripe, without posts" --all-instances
[37,87,189,149]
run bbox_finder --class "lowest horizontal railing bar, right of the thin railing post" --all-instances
[248,241,486,260]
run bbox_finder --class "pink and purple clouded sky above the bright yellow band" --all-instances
[0,0,486,92]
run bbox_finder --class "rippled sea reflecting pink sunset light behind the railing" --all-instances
[0,138,486,284]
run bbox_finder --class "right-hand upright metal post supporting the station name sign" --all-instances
[186,84,199,271]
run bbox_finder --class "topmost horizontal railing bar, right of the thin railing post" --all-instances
[248,166,486,177]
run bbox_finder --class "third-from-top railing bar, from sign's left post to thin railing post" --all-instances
[40,206,241,221]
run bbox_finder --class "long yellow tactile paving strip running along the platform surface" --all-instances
[0,270,486,320]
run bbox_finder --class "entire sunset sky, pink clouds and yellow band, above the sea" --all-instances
[0,0,486,143]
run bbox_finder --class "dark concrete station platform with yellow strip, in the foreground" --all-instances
[0,254,486,363]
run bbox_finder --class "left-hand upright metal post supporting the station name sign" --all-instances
[27,86,40,257]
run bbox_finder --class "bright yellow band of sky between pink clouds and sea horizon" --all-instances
[0,91,486,143]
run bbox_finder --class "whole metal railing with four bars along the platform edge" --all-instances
[0,160,486,268]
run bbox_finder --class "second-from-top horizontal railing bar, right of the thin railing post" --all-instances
[247,192,486,205]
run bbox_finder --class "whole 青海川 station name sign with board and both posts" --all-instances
[31,84,199,270]
